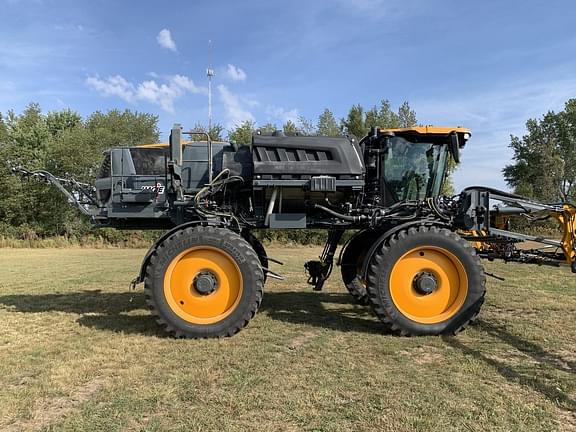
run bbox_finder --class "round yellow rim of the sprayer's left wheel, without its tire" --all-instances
[164,246,244,324]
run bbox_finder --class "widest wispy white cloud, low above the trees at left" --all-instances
[86,75,207,113]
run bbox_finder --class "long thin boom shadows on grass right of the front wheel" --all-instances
[443,320,576,412]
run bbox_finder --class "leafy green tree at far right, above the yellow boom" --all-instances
[503,99,576,202]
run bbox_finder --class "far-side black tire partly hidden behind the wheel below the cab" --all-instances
[340,230,379,306]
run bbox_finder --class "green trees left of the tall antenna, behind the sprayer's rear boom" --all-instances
[0,103,159,239]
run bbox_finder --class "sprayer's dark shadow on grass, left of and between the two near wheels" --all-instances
[0,290,386,336]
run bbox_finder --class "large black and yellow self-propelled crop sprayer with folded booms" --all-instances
[14,125,576,338]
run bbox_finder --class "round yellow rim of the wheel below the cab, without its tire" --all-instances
[390,246,468,324]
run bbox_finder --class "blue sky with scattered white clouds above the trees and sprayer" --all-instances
[0,0,576,189]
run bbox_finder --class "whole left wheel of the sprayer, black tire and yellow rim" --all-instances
[144,226,264,338]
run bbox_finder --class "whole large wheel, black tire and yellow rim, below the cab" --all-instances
[368,226,486,336]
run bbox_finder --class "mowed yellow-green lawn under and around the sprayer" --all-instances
[0,247,576,431]
